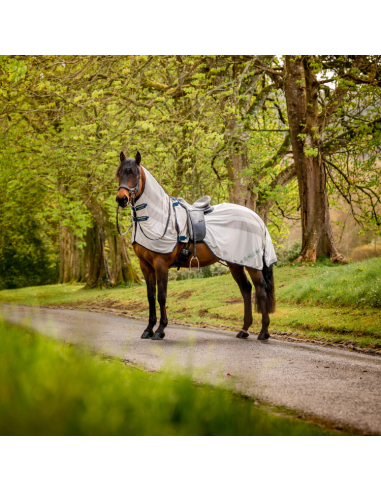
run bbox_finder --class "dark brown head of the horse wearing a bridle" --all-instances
[116,152,143,208]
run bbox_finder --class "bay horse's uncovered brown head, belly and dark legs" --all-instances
[116,152,276,340]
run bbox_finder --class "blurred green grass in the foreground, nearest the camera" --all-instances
[0,322,332,436]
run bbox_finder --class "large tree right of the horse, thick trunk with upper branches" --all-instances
[267,55,379,263]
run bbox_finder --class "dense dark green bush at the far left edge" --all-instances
[0,140,58,289]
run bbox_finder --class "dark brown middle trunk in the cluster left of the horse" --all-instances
[85,223,112,289]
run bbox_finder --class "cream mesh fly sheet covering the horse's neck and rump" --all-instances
[132,168,277,270]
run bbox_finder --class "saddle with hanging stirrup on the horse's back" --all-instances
[170,196,214,272]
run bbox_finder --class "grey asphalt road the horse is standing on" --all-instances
[3,307,381,434]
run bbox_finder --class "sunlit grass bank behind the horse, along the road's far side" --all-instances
[0,258,381,347]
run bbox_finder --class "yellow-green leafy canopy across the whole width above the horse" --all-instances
[0,55,381,285]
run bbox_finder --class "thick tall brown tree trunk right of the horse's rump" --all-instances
[285,55,345,263]
